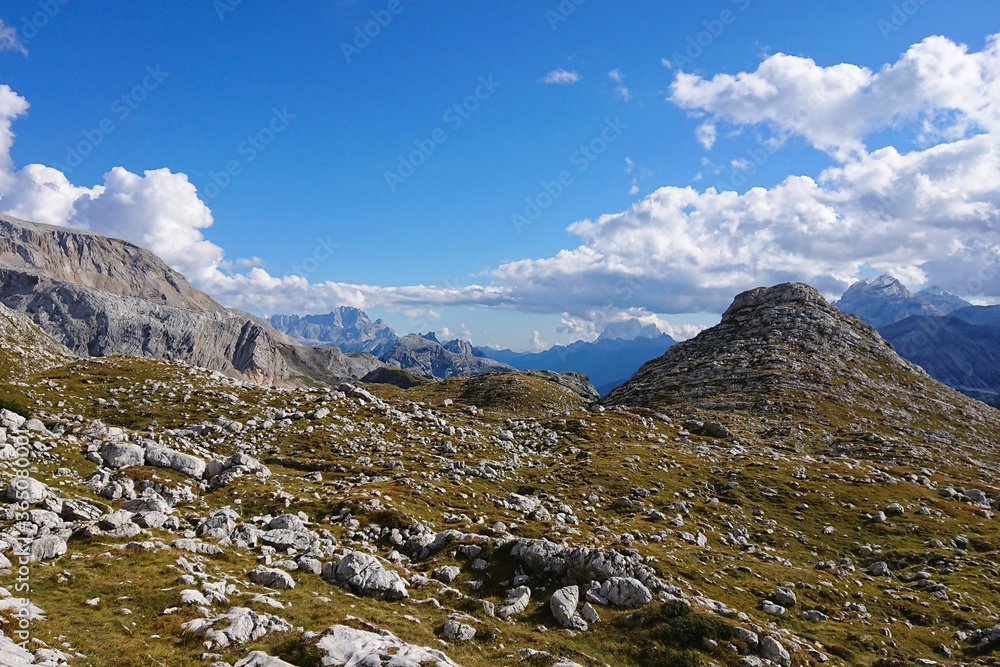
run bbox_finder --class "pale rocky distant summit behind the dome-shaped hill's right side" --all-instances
[833,275,970,327]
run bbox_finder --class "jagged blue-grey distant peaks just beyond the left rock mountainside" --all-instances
[270,306,399,357]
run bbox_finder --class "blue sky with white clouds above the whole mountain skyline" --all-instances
[0,0,1000,349]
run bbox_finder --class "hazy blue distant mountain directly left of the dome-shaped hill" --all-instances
[480,319,677,395]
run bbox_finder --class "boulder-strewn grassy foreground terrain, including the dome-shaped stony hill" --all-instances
[0,285,1000,667]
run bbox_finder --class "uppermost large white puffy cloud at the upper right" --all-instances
[670,35,1000,161]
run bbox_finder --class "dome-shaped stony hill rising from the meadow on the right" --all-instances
[603,283,995,439]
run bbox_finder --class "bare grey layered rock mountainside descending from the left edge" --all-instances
[0,217,381,385]
